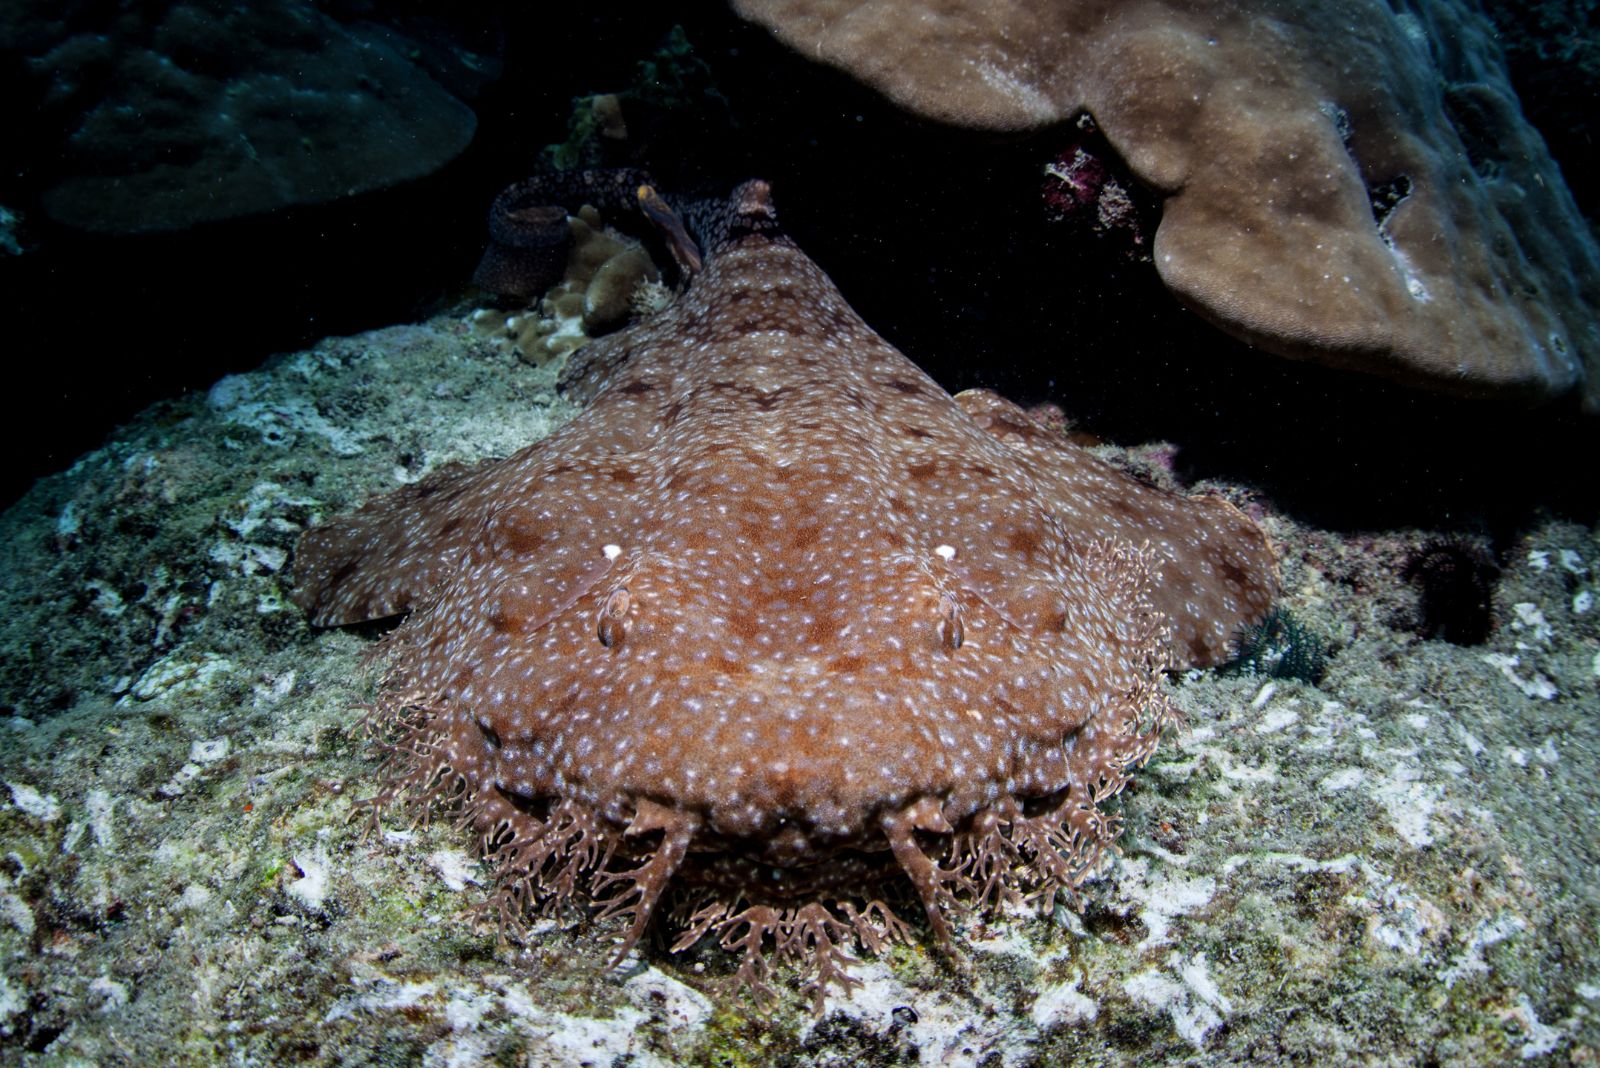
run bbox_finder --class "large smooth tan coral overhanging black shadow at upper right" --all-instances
[734,0,1600,408]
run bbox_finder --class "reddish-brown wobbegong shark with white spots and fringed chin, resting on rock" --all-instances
[294,182,1277,1004]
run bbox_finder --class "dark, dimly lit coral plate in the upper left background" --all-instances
[0,0,498,232]
